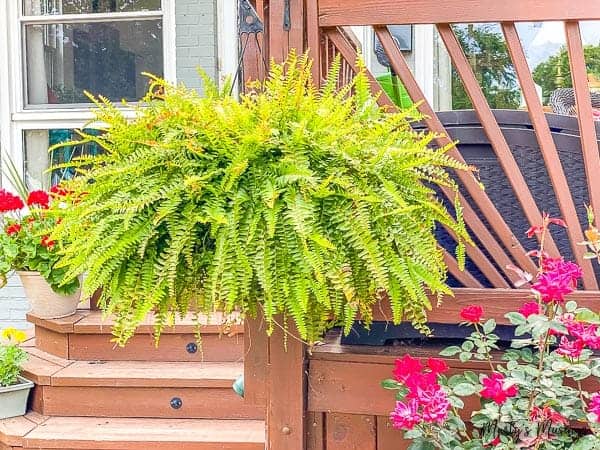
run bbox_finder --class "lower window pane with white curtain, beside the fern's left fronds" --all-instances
[23,129,102,189]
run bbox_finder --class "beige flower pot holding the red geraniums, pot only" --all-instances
[17,272,81,319]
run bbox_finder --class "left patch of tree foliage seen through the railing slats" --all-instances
[452,25,521,109]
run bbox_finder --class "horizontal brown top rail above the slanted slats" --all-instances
[319,0,600,27]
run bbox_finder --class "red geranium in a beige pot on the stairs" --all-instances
[0,161,81,319]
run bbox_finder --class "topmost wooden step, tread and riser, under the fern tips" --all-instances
[28,310,244,362]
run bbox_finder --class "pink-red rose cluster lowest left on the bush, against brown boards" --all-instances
[390,355,450,430]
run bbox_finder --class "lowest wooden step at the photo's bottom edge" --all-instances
[0,415,265,450]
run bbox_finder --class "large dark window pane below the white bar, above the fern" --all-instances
[26,20,163,105]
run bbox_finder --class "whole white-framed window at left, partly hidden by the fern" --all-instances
[0,0,176,188]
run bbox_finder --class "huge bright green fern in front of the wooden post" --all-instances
[54,54,469,344]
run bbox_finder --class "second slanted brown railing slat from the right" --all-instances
[502,22,600,289]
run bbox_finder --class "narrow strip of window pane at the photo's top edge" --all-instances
[23,0,160,16]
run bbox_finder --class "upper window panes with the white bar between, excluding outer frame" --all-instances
[20,0,164,109]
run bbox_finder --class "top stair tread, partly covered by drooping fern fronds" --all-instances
[27,310,244,335]
